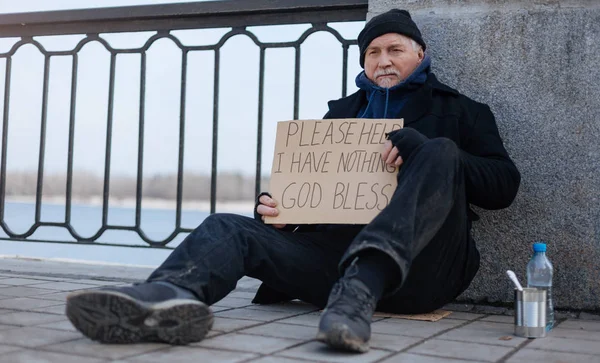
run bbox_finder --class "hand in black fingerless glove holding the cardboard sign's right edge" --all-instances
[381,127,428,166]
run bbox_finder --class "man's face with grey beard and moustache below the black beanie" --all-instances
[365,33,424,88]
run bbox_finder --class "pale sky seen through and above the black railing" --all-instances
[0,0,364,176]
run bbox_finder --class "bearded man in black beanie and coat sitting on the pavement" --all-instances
[66,10,520,352]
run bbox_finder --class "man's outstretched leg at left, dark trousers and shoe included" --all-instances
[67,214,351,344]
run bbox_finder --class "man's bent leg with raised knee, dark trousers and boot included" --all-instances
[318,138,474,351]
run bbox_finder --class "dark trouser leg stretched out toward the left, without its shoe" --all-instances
[148,214,351,306]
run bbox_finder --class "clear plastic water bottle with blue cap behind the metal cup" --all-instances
[527,242,554,331]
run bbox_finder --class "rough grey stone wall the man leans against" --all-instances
[369,0,600,311]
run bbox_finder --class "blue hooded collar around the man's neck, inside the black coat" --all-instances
[356,55,431,118]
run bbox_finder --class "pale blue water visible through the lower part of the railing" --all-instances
[0,203,251,267]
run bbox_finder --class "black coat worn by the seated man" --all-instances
[253,73,521,303]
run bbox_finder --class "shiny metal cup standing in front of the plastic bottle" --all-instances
[515,287,546,338]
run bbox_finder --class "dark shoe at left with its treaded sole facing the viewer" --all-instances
[66,283,213,345]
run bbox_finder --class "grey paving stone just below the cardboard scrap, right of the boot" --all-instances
[371,319,464,338]
